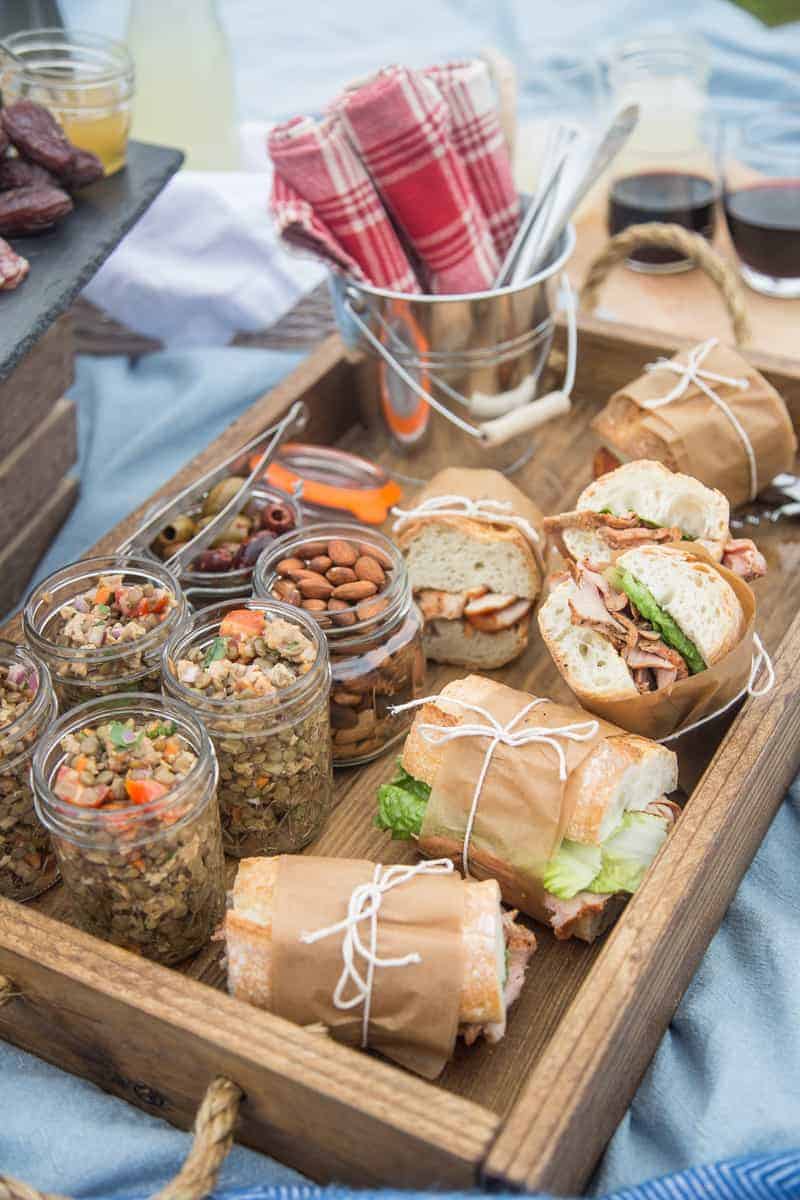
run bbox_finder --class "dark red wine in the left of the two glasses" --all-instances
[608,170,717,271]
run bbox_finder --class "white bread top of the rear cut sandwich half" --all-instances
[563,460,730,565]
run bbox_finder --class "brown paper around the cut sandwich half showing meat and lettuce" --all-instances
[563,541,756,742]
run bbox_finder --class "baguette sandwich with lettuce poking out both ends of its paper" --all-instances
[375,677,679,942]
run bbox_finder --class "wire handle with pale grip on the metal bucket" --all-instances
[344,272,578,448]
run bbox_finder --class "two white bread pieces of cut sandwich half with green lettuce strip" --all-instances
[539,546,745,701]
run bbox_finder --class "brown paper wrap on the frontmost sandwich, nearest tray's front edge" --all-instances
[272,856,464,1079]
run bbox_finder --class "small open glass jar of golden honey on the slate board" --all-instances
[0,29,133,175]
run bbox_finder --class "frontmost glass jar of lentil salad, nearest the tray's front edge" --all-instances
[32,692,225,964]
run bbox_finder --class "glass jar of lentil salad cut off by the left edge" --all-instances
[0,642,59,900]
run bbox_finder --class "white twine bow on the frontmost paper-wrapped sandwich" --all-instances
[300,858,453,1049]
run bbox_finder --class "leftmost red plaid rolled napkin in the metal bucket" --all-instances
[267,116,420,293]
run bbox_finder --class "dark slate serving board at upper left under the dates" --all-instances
[0,142,184,380]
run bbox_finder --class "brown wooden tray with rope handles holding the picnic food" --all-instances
[0,320,800,1193]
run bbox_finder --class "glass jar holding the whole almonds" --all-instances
[253,522,426,767]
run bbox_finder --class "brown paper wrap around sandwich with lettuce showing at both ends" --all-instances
[419,676,622,925]
